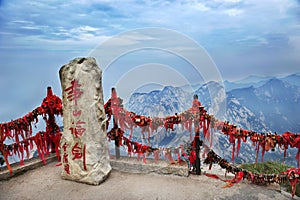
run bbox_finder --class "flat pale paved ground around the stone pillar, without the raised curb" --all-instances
[0,162,291,200]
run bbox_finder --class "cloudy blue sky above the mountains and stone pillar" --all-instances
[0,0,300,122]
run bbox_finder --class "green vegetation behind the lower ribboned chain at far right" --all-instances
[240,161,300,196]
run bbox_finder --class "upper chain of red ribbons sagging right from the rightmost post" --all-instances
[213,120,300,167]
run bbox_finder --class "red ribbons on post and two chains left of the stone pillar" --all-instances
[0,87,62,174]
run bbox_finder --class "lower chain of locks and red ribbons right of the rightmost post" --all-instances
[204,150,300,197]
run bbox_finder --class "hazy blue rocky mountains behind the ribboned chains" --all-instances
[125,74,300,165]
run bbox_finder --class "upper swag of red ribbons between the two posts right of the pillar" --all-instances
[104,88,211,144]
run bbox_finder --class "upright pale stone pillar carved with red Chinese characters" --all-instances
[59,58,111,185]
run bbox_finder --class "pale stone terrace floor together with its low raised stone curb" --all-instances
[0,155,300,200]
